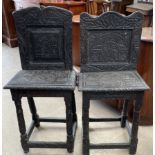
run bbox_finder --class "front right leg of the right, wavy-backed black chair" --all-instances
[129,94,143,154]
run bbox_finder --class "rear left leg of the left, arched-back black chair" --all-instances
[27,97,40,127]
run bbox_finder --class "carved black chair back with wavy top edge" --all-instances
[80,12,143,72]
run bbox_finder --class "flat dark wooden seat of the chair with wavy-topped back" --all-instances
[79,71,149,91]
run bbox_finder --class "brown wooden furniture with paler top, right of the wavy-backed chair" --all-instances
[137,27,153,125]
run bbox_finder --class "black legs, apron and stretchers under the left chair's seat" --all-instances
[8,89,77,153]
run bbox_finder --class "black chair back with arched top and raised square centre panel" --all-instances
[13,7,72,70]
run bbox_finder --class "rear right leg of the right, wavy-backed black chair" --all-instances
[121,100,129,128]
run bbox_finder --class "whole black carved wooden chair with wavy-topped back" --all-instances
[79,12,148,155]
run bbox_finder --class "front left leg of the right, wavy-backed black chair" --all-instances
[82,94,90,155]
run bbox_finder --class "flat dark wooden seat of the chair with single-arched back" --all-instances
[4,70,76,90]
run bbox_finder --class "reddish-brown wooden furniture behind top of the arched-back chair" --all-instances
[40,0,86,15]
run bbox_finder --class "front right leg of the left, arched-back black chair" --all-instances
[64,94,74,153]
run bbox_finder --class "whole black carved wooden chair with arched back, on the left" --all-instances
[4,7,77,153]
